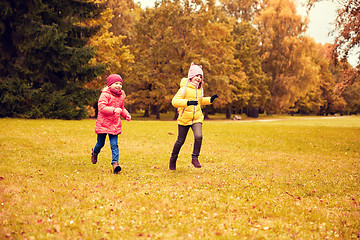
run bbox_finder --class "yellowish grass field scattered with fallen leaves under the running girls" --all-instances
[0,117,360,239]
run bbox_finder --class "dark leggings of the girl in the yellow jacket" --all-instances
[171,123,202,159]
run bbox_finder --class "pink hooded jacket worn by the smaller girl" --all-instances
[95,89,129,135]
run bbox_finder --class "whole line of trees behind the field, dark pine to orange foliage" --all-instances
[0,0,360,119]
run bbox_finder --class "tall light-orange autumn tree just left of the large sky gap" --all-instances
[255,0,319,112]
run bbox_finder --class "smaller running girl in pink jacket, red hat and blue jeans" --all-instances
[91,74,131,174]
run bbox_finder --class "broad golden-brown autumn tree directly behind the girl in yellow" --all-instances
[129,0,237,118]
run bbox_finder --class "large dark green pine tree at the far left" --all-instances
[0,0,103,119]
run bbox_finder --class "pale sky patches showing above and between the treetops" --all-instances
[135,0,360,66]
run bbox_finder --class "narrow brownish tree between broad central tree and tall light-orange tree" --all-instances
[217,0,269,118]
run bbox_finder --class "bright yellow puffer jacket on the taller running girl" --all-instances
[171,78,211,126]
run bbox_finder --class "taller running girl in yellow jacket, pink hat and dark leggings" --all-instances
[169,63,218,170]
